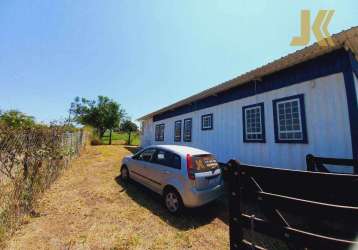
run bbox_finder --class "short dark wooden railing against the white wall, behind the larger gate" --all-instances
[306,154,358,174]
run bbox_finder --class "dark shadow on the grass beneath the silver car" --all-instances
[115,176,229,231]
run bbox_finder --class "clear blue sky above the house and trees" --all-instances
[0,0,358,122]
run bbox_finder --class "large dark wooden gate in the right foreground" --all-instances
[227,160,358,249]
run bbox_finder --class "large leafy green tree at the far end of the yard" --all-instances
[70,96,125,144]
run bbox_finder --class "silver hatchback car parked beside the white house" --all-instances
[121,145,224,214]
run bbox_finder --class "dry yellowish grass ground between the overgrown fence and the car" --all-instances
[7,146,228,250]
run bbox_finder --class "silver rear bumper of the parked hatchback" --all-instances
[182,183,224,207]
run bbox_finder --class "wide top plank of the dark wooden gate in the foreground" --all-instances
[237,165,358,206]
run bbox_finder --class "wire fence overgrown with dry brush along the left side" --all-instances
[0,126,87,242]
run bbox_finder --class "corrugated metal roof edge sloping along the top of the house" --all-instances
[138,26,358,120]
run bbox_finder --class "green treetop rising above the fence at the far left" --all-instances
[0,110,35,128]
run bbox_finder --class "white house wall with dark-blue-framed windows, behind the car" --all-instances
[142,73,357,170]
